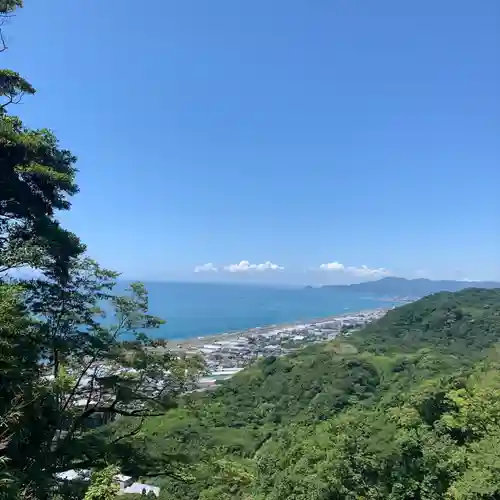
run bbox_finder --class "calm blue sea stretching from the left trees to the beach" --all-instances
[132,282,396,339]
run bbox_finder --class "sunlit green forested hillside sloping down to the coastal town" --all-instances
[120,289,500,500]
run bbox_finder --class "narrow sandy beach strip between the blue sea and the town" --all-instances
[172,307,392,350]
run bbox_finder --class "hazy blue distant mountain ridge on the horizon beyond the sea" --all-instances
[322,277,500,298]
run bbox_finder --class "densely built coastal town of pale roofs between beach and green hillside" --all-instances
[176,308,388,390]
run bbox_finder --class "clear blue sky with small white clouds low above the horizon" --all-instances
[2,0,500,283]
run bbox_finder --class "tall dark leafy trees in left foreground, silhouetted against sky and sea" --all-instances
[0,0,202,500]
